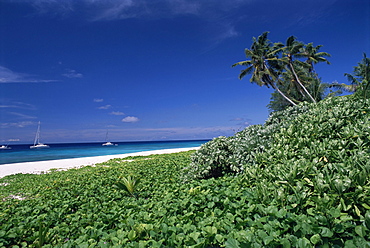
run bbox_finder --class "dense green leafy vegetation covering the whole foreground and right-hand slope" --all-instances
[0,97,370,247]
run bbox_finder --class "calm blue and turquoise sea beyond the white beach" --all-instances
[0,140,208,165]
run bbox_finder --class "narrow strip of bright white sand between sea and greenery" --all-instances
[0,147,199,178]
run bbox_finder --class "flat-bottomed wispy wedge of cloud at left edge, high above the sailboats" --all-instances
[0,66,57,83]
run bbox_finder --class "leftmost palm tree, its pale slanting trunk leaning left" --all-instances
[232,32,296,105]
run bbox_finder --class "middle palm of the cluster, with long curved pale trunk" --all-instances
[274,36,316,103]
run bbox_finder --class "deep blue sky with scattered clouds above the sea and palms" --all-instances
[0,0,370,143]
